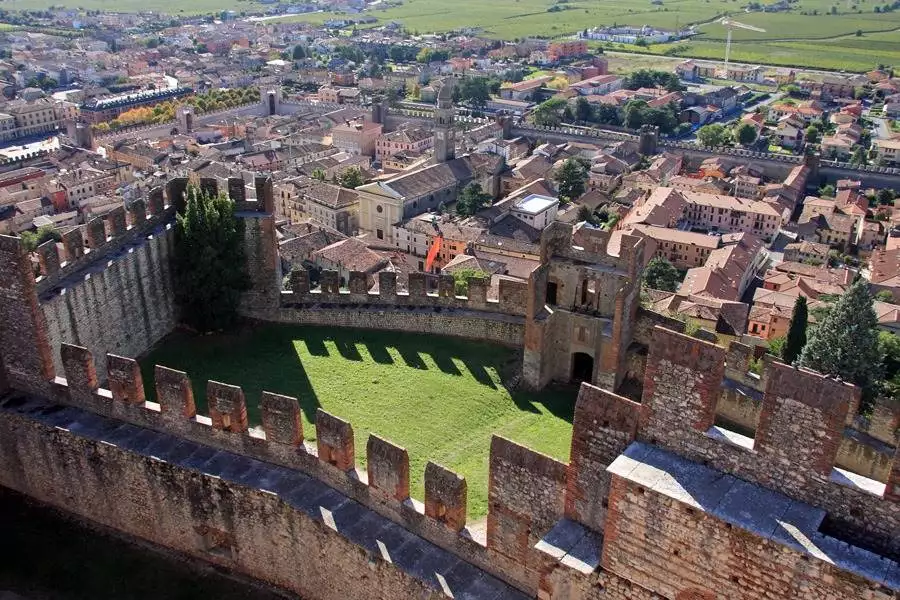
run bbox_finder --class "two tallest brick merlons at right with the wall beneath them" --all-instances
[637,327,900,558]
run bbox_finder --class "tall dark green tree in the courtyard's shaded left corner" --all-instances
[173,187,249,331]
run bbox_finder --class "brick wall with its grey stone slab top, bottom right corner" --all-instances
[601,448,894,600]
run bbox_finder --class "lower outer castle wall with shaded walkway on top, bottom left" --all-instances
[0,401,524,600]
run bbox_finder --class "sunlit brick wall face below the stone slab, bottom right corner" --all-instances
[602,476,894,600]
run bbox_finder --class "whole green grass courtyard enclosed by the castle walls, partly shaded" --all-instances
[141,325,576,519]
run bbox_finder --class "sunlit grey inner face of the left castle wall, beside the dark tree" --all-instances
[41,227,177,380]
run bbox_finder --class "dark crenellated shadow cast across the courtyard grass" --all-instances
[141,325,577,425]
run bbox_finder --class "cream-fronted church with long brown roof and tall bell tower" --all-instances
[356,80,504,245]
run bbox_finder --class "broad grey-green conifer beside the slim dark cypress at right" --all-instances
[800,278,881,398]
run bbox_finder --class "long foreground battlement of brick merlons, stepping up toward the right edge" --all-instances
[33,340,900,599]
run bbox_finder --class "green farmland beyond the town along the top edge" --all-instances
[7,0,900,71]
